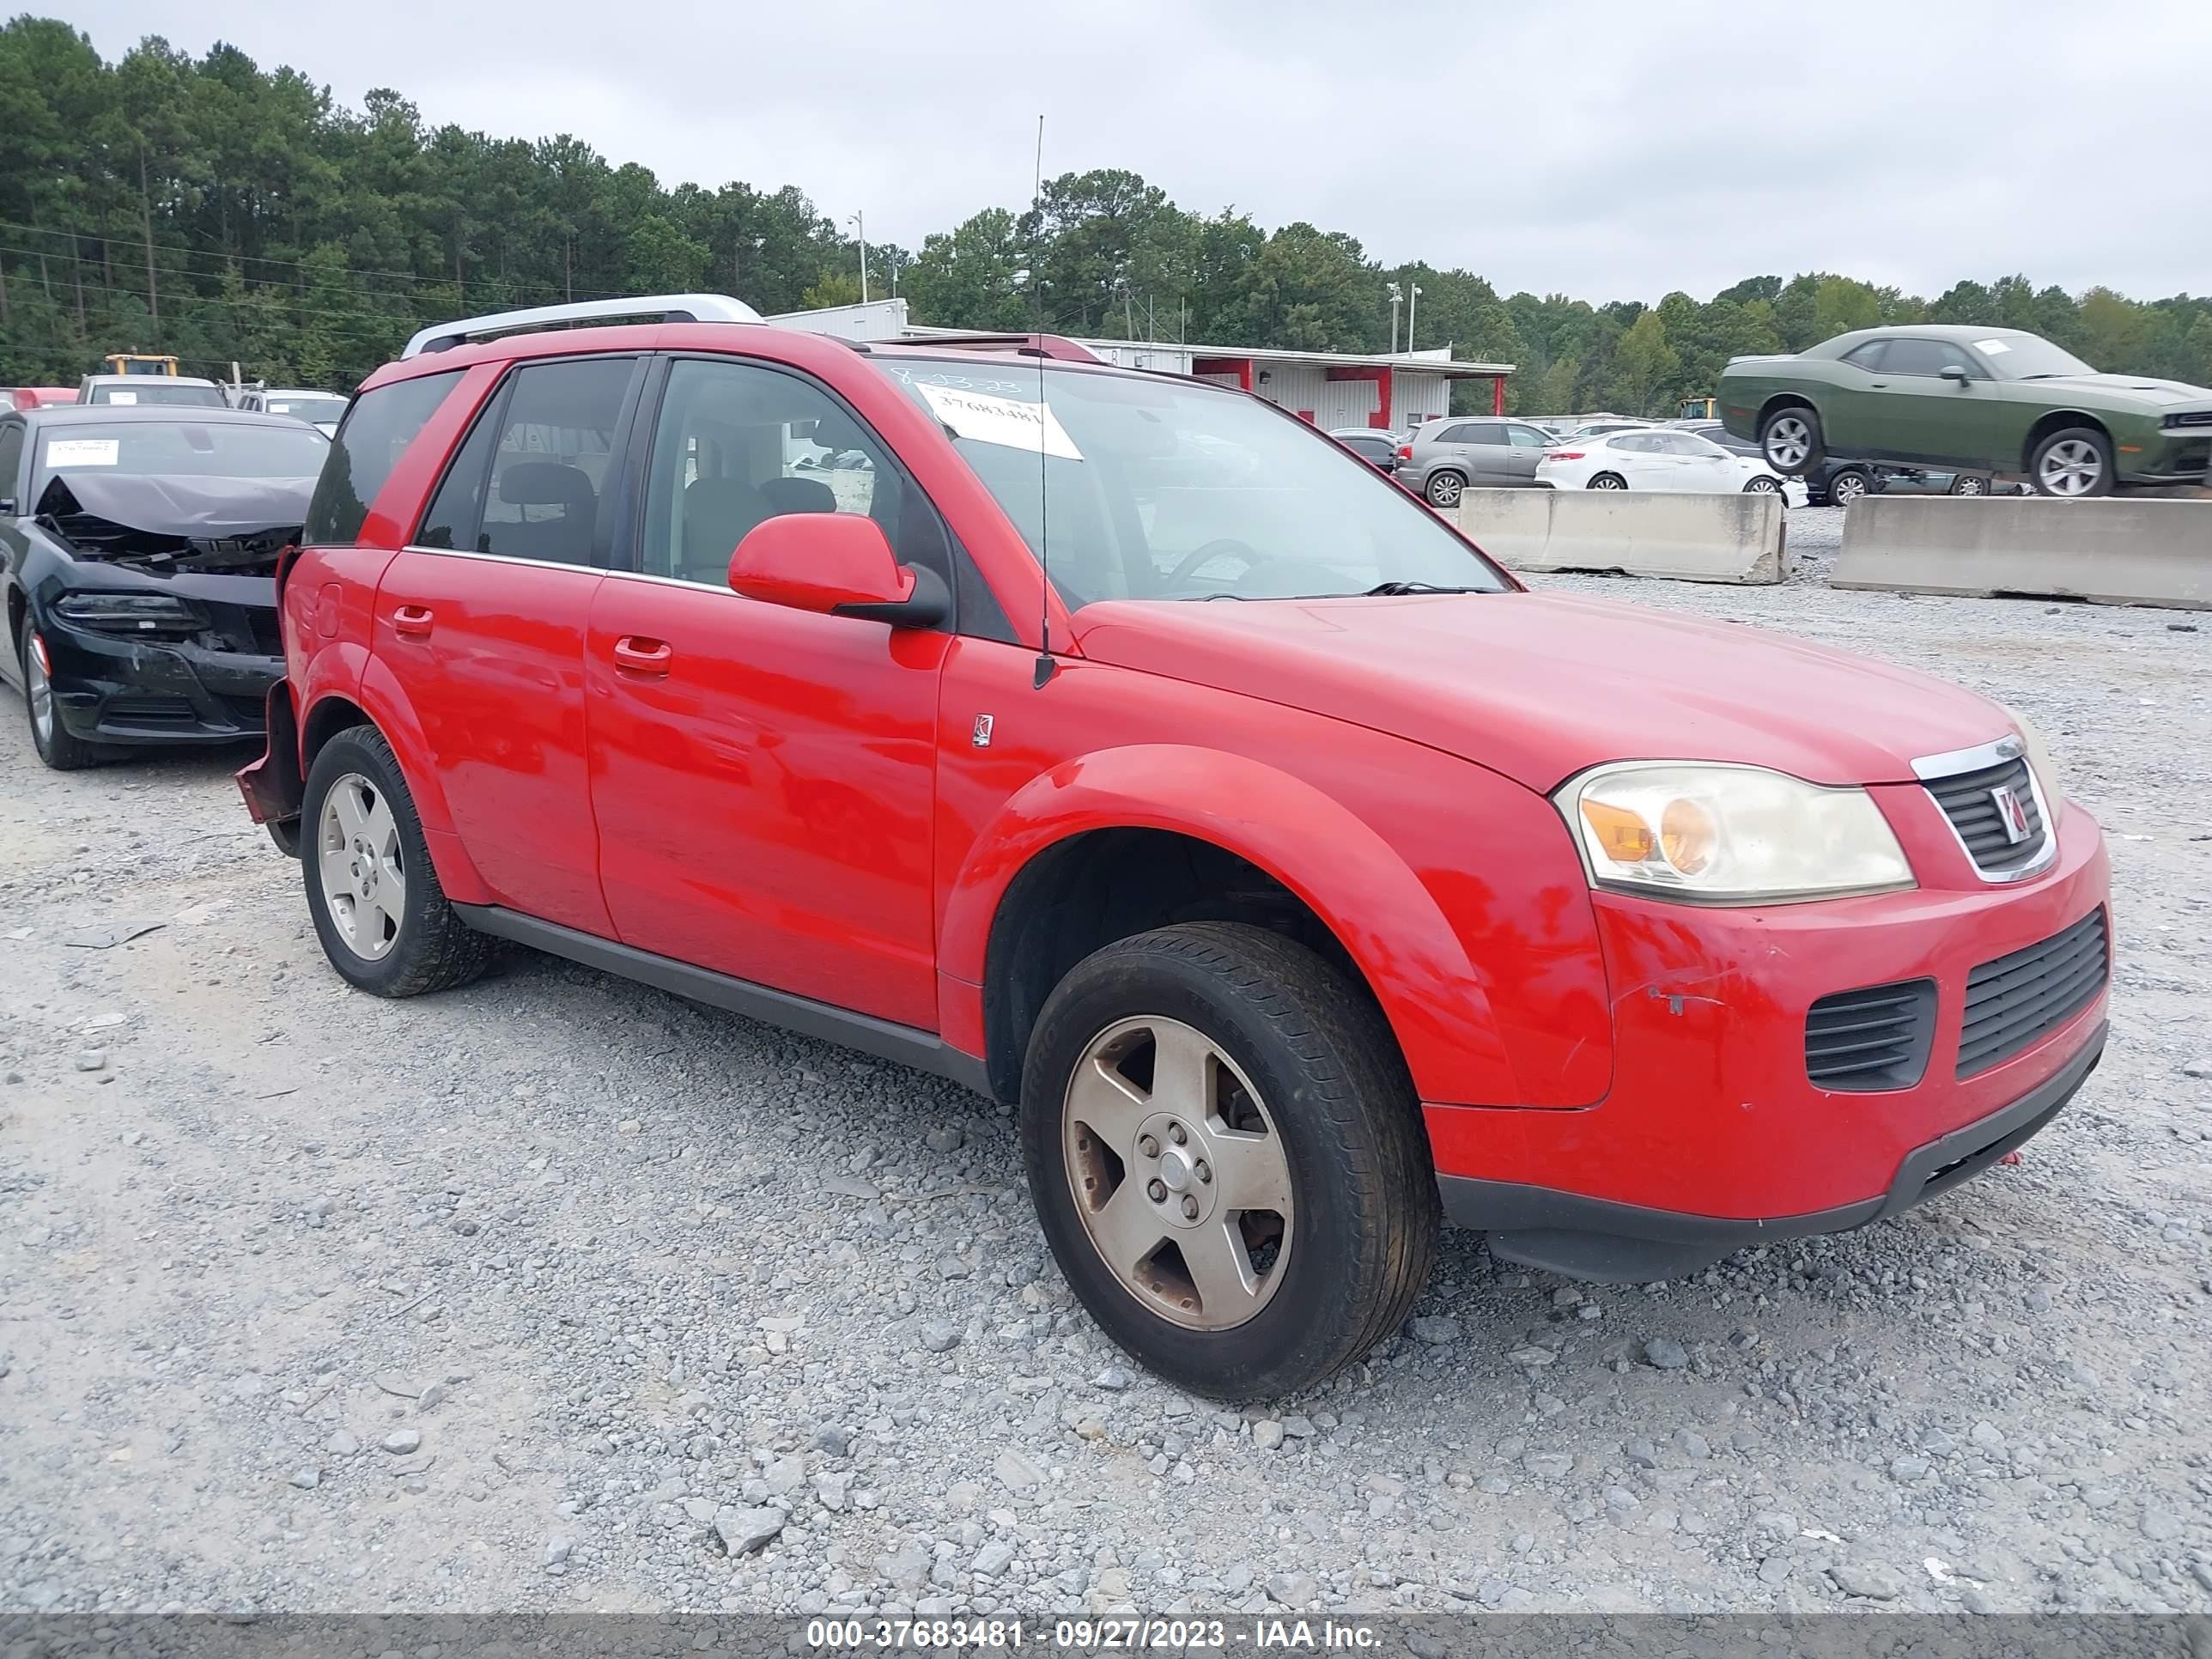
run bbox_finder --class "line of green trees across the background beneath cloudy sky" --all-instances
[0,15,2212,414]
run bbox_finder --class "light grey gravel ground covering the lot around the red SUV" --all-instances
[0,542,2212,1613]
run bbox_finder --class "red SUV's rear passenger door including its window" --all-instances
[372,356,644,938]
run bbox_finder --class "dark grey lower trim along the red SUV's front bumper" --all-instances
[1437,1022,2104,1285]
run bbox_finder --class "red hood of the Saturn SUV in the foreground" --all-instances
[1075,592,2011,792]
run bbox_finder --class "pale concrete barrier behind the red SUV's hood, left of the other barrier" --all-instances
[1460,489,1790,584]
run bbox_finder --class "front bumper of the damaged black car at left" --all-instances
[38,617,283,744]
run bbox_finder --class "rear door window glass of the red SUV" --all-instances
[416,356,637,564]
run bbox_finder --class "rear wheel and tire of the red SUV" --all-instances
[299,726,493,998]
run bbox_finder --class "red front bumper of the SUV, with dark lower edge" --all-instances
[1425,800,2111,1279]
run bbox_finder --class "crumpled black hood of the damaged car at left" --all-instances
[35,471,314,573]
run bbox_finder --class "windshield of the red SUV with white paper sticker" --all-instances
[878,358,1506,611]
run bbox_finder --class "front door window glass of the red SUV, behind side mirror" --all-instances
[639,358,953,610]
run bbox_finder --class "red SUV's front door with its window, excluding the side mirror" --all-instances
[584,358,949,1030]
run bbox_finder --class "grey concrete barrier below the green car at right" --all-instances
[1829,506,2212,611]
